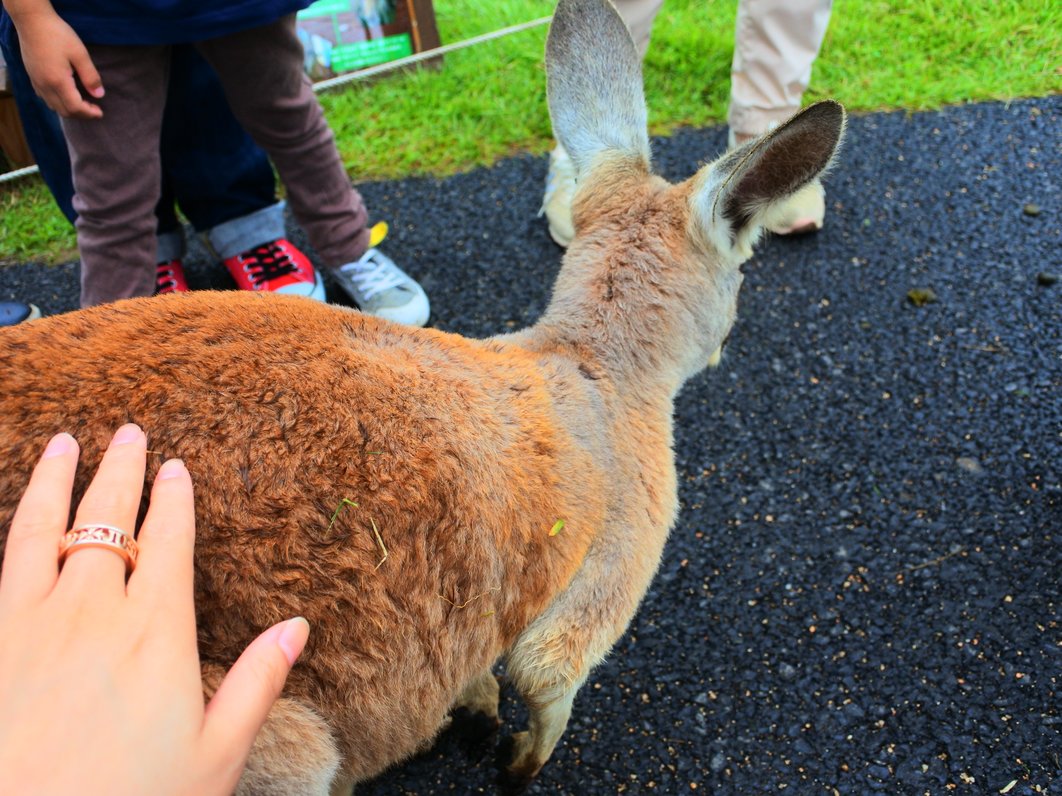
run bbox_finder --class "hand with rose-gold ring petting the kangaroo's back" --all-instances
[0,425,309,795]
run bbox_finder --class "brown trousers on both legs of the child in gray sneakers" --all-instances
[63,16,369,307]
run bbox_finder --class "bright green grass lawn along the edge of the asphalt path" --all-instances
[0,0,1062,261]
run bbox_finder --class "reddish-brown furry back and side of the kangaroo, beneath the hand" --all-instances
[0,293,604,781]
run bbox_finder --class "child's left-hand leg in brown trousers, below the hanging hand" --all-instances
[63,45,169,307]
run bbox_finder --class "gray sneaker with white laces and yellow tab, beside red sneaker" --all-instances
[331,222,431,326]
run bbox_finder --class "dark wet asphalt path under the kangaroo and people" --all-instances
[0,96,1062,796]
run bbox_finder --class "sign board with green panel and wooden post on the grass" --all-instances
[297,0,439,81]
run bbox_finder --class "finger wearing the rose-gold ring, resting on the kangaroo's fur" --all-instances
[59,423,148,594]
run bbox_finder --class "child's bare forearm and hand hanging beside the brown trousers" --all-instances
[3,0,103,119]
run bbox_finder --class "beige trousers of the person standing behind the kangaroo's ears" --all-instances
[615,0,833,139]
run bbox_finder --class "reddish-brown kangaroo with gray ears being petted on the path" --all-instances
[0,0,844,796]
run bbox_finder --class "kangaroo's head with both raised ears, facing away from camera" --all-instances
[543,0,844,388]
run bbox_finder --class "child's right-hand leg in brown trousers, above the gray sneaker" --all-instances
[196,16,369,267]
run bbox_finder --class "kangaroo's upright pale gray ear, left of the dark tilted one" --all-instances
[546,0,649,176]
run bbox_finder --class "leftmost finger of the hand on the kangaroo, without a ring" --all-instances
[0,434,78,605]
